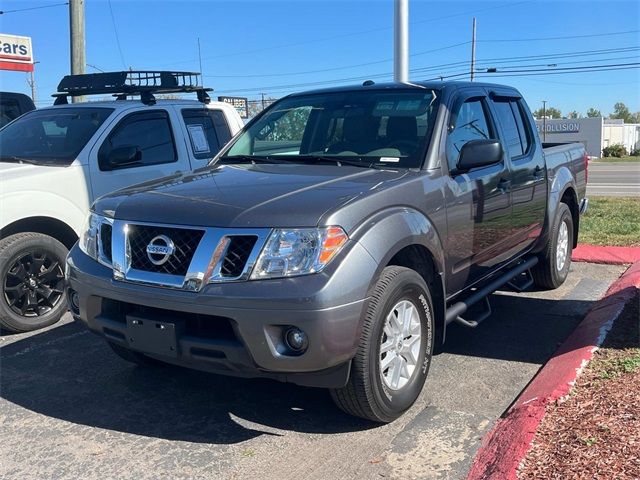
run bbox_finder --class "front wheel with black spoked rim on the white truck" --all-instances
[0,232,69,332]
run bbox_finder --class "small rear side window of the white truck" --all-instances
[182,108,231,159]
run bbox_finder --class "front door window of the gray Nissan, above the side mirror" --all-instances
[446,99,493,170]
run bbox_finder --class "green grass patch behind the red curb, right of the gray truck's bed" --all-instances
[578,197,640,247]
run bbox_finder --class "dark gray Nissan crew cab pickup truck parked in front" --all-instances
[67,82,587,422]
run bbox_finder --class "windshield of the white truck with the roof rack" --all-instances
[0,107,113,165]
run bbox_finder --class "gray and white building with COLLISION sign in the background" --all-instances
[536,117,640,157]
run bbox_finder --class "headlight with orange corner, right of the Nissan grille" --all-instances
[251,227,348,280]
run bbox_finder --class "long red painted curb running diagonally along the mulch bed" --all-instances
[467,261,640,480]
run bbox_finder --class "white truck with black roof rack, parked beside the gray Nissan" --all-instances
[0,72,243,331]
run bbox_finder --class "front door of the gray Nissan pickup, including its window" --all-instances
[445,90,511,293]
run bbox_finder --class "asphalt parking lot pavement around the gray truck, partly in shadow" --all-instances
[0,264,625,479]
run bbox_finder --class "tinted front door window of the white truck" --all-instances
[98,110,178,170]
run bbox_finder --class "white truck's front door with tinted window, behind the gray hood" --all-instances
[90,108,190,198]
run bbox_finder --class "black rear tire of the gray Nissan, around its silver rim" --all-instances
[531,203,574,290]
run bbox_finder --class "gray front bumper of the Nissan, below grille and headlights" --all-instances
[67,243,375,387]
